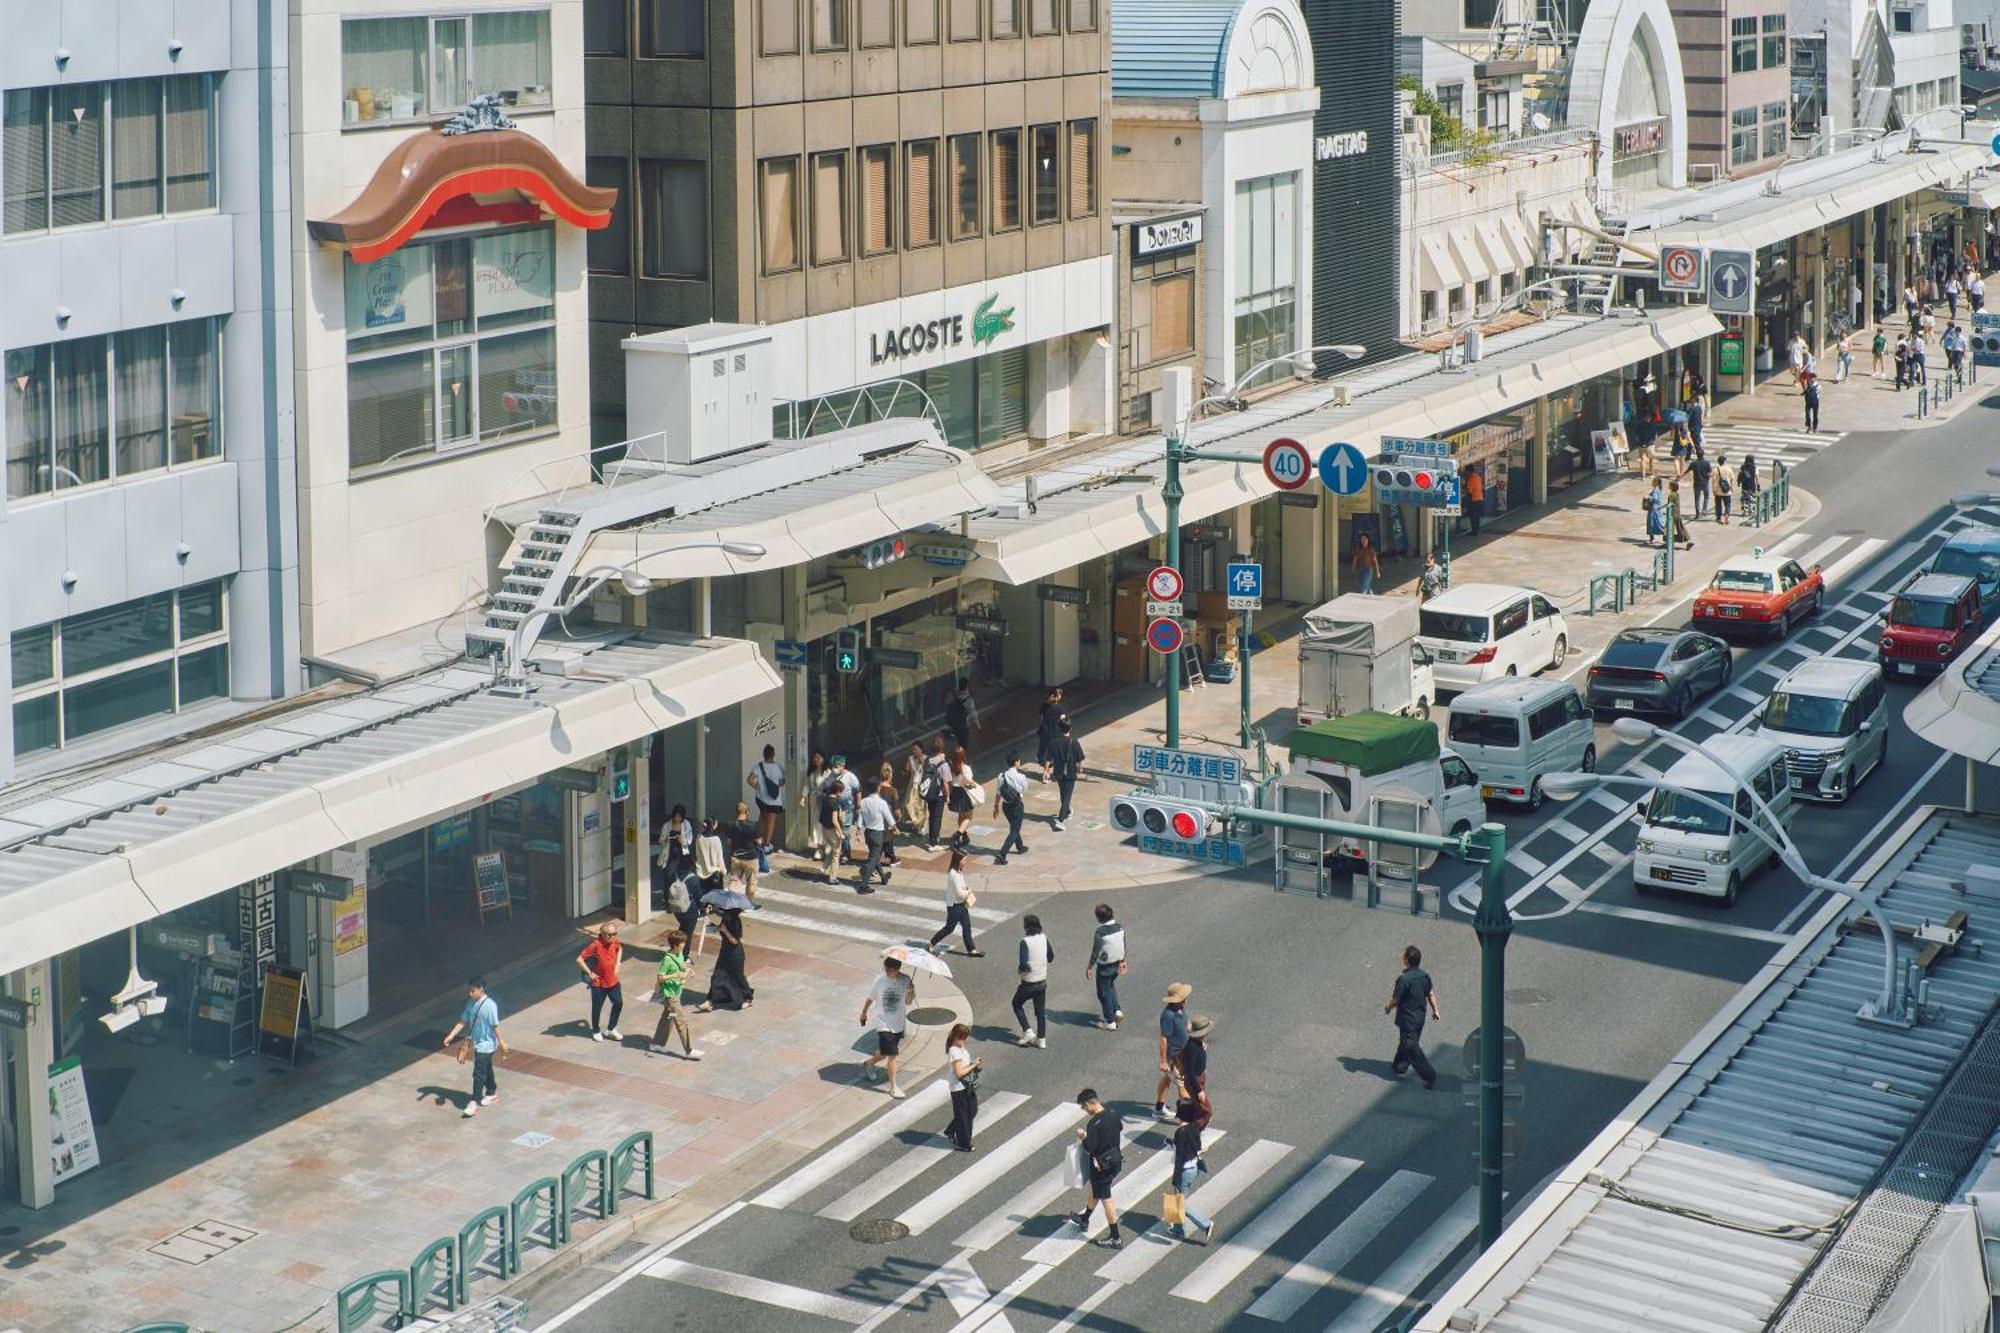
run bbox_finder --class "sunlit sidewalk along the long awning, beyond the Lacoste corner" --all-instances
[772,460,1820,904]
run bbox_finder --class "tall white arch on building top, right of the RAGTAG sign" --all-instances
[1570,0,1688,201]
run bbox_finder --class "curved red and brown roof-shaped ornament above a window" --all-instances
[306,111,618,264]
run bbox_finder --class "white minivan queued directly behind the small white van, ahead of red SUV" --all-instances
[1756,656,1888,801]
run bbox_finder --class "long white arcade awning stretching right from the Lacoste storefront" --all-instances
[966,306,1722,584]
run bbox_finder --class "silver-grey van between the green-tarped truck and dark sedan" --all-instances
[1444,679,1598,811]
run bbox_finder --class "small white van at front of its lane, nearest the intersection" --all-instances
[1632,735,1794,907]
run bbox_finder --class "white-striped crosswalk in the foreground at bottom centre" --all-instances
[556,1079,1476,1333]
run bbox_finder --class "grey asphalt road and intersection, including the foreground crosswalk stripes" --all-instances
[528,396,2000,1333]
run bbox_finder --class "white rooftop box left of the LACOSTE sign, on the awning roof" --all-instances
[624,324,770,462]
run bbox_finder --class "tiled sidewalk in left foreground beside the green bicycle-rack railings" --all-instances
[0,917,970,1333]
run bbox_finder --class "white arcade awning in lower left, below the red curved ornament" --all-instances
[0,632,780,973]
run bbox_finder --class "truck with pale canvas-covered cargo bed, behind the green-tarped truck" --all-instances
[1298,592,1438,727]
